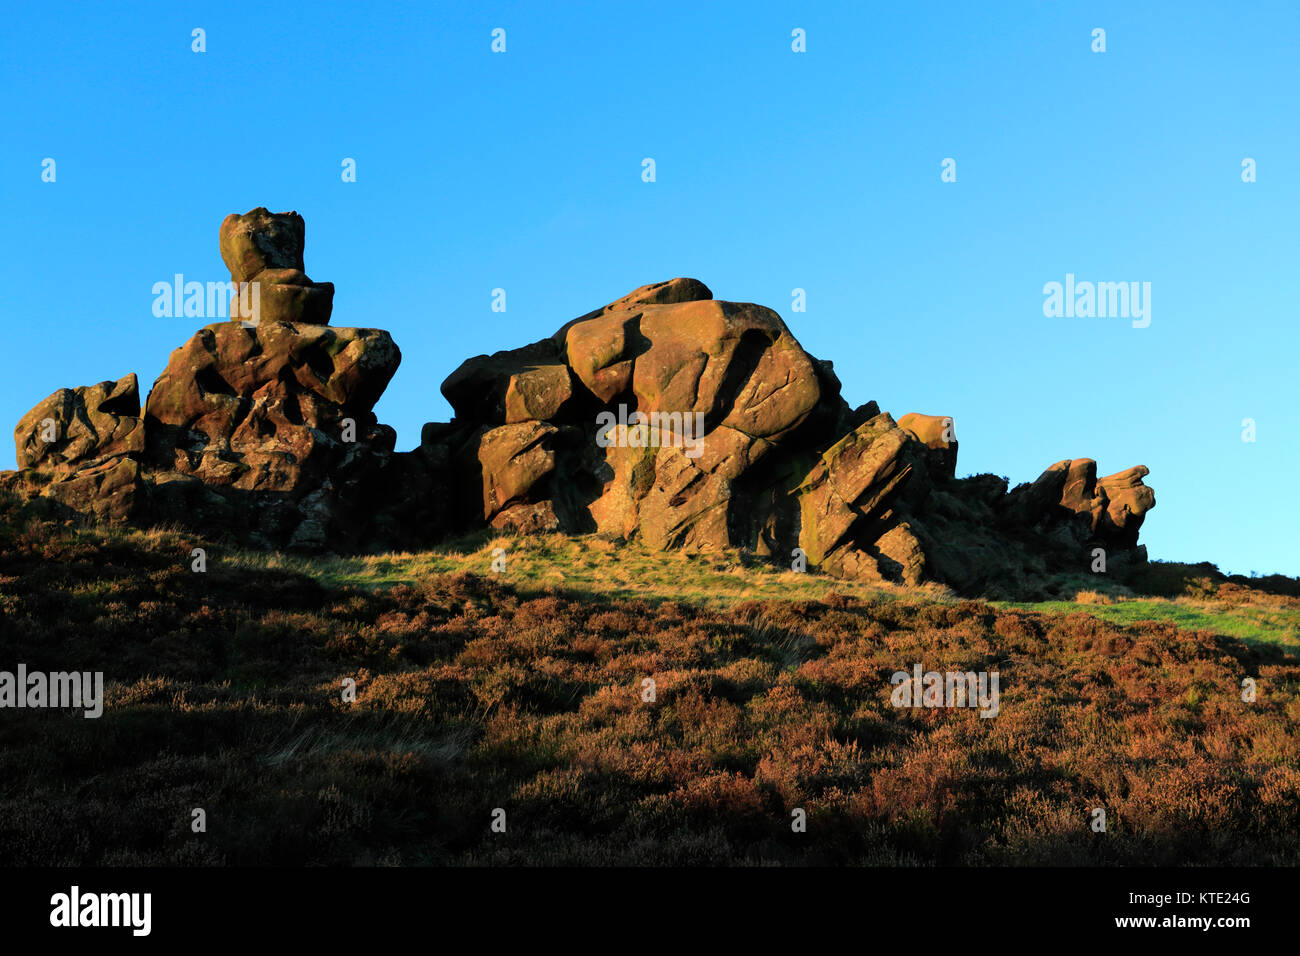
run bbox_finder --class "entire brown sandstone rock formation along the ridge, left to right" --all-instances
[0,208,1154,593]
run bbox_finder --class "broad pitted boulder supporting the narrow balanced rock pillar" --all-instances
[144,320,402,549]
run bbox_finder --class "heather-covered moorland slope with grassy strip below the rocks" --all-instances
[0,506,1300,865]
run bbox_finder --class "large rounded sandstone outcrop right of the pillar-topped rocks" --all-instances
[428,280,1145,587]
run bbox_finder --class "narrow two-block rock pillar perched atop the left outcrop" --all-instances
[220,206,334,325]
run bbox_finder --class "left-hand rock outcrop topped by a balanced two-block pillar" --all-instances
[0,208,444,550]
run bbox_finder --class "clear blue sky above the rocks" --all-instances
[0,1,1300,575]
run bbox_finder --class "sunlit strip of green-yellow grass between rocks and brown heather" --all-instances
[61,515,1300,654]
